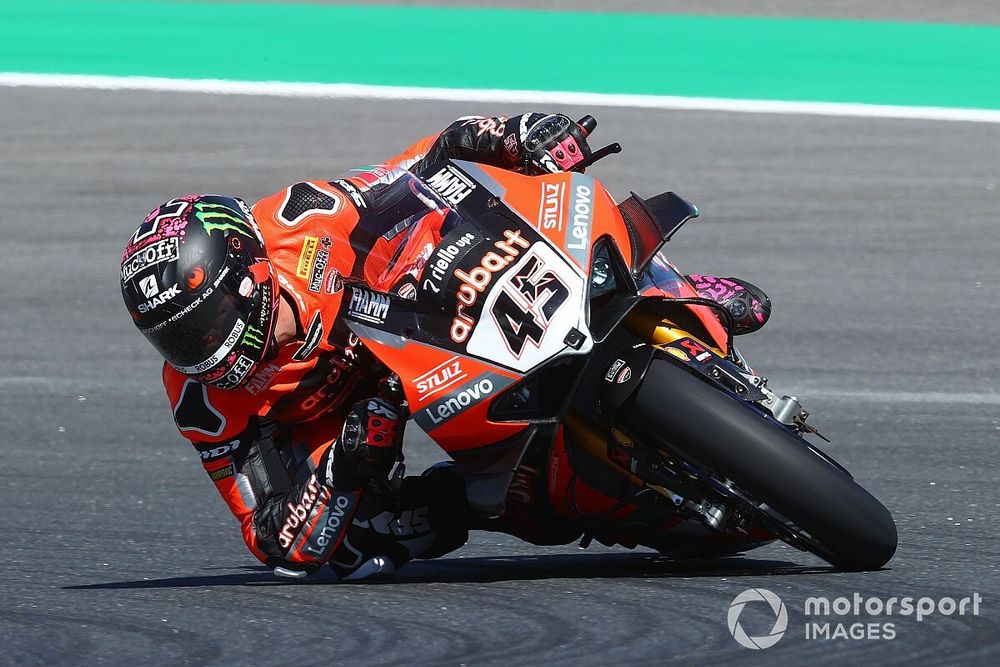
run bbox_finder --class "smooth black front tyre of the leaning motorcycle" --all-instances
[618,358,897,570]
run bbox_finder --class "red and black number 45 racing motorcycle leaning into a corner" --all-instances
[344,117,897,570]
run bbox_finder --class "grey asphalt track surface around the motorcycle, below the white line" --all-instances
[0,88,1000,665]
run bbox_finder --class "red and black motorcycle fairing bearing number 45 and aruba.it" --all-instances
[344,161,760,546]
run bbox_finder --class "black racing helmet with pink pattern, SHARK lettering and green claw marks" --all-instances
[121,195,278,389]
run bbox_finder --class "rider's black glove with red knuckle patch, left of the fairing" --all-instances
[333,398,403,488]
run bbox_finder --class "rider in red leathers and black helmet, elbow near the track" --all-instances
[121,113,766,579]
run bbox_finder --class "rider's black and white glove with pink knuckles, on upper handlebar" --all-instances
[504,113,590,176]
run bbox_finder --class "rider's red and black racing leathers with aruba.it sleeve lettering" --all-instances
[163,114,560,572]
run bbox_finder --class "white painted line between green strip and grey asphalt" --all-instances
[0,72,1000,123]
